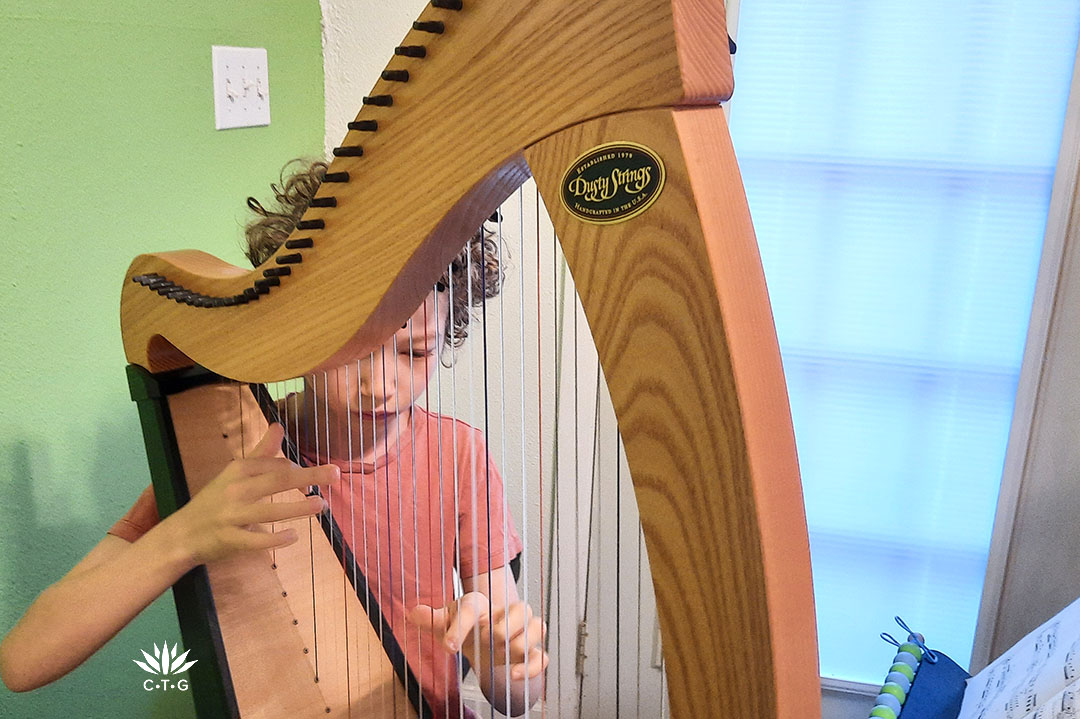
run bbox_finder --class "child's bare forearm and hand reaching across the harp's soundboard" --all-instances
[0,424,338,691]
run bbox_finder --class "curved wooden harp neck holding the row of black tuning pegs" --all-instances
[121,0,730,381]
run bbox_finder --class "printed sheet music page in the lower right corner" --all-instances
[957,599,1080,719]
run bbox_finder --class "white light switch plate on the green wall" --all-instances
[212,45,270,130]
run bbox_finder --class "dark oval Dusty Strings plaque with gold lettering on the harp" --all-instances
[559,143,665,225]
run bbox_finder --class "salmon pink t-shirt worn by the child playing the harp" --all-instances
[109,407,522,718]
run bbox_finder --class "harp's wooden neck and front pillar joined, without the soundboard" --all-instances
[122,0,820,719]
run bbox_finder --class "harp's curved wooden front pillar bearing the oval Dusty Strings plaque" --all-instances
[525,107,821,719]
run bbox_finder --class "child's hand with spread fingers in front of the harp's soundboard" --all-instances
[166,424,339,566]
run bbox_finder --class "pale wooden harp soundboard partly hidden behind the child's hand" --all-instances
[168,384,416,719]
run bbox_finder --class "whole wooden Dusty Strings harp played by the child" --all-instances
[121,0,820,719]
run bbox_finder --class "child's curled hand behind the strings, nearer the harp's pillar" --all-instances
[407,592,549,680]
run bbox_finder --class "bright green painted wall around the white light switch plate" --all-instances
[0,0,324,719]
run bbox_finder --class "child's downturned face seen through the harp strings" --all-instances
[315,291,449,424]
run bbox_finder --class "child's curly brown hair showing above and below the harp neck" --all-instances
[244,160,503,349]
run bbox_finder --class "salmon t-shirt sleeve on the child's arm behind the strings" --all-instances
[458,428,522,578]
